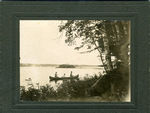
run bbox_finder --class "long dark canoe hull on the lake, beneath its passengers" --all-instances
[49,75,79,81]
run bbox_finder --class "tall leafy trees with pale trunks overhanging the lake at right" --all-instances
[59,20,130,95]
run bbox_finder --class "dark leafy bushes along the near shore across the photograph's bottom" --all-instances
[20,75,126,102]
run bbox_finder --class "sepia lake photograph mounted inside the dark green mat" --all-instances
[20,20,131,102]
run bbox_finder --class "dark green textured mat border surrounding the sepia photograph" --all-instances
[0,1,149,113]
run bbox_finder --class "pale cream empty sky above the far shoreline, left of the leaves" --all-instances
[20,20,101,65]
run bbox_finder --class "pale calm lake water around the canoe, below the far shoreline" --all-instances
[20,67,103,87]
